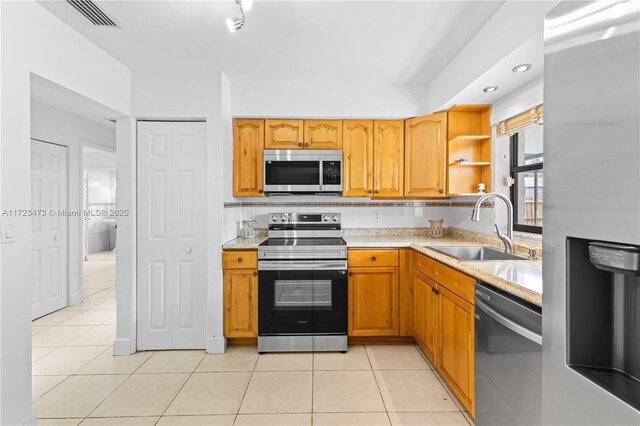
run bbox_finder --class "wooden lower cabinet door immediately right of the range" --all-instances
[349,267,399,336]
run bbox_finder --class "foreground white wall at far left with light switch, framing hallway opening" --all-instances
[0,1,129,425]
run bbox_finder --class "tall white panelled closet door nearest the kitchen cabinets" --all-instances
[137,122,206,350]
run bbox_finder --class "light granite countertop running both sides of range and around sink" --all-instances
[222,233,542,306]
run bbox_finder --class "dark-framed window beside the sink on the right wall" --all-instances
[510,125,544,234]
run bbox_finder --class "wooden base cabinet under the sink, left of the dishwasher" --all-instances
[413,253,475,417]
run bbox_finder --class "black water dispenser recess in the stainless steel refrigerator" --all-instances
[567,237,640,410]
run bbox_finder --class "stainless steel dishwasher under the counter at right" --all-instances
[475,283,542,426]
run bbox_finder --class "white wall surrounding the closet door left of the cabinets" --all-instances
[114,70,231,354]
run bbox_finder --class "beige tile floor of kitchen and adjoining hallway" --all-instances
[33,253,470,426]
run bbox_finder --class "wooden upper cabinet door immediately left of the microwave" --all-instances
[233,120,264,197]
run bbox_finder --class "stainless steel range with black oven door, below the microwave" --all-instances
[258,213,347,352]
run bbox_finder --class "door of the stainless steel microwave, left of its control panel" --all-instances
[264,150,322,192]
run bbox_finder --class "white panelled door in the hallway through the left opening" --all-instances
[31,140,68,319]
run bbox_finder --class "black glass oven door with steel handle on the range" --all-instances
[258,261,347,336]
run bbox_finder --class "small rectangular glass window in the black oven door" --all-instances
[274,280,331,310]
